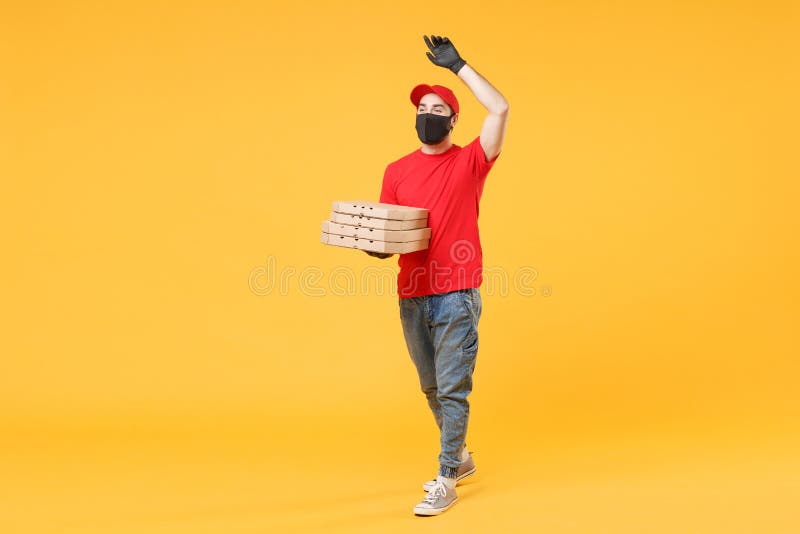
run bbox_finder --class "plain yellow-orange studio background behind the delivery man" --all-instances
[0,0,800,534]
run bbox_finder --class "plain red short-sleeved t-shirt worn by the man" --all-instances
[380,137,497,298]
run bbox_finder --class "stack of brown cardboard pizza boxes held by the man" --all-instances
[320,200,431,254]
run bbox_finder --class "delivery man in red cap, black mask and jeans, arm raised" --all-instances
[368,36,508,515]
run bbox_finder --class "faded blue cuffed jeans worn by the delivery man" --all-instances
[399,288,482,478]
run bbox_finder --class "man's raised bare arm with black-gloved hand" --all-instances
[423,35,508,161]
